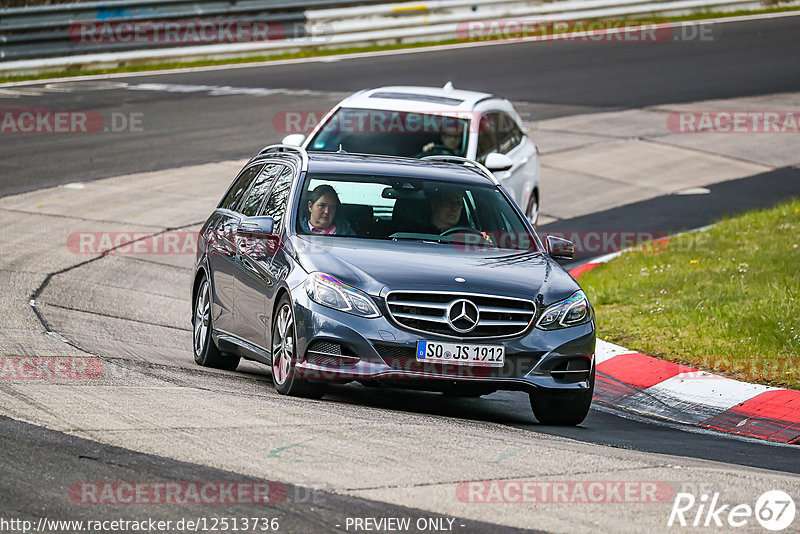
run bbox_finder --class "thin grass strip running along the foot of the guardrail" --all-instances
[0,6,800,83]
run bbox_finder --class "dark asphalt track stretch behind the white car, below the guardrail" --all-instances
[0,16,800,196]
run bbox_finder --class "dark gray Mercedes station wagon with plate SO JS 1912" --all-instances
[192,145,595,425]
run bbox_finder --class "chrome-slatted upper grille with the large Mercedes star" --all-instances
[386,291,536,338]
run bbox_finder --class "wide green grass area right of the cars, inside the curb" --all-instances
[580,199,800,390]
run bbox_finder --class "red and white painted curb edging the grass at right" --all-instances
[570,252,800,444]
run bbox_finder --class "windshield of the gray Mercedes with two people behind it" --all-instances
[296,174,538,251]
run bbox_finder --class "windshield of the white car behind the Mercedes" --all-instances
[308,108,470,158]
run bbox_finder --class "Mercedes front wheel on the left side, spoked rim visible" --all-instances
[270,295,326,399]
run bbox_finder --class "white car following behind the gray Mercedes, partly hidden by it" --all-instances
[283,83,539,224]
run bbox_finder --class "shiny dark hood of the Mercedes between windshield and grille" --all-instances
[292,236,579,305]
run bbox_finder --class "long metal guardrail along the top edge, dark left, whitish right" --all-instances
[0,0,788,73]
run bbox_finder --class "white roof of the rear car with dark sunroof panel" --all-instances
[340,83,498,113]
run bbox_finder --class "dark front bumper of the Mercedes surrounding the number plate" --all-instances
[293,292,595,393]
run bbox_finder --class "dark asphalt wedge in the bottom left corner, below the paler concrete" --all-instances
[0,417,532,534]
